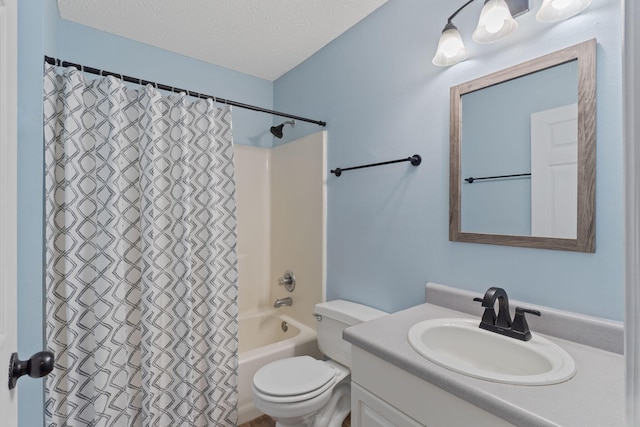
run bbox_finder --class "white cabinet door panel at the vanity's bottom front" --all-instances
[351,382,422,427]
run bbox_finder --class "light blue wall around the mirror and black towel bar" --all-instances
[274,0,624,320]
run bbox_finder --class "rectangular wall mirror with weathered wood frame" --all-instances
[449,39,596,252]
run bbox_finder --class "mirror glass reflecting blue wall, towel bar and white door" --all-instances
[461,61,578,239]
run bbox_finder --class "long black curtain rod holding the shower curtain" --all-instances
[44,55,327,126]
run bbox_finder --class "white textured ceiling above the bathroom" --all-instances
[58,0,387,80]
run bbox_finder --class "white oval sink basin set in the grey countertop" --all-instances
[408,318,576,385]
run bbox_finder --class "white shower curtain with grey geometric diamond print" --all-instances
[44,65,238,427]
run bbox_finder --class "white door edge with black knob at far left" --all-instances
[0,0,18,427]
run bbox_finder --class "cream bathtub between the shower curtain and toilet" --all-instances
[238,310,320,424]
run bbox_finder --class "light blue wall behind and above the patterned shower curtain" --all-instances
[18,0,273,427]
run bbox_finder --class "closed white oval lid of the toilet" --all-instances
[253,356,335,396]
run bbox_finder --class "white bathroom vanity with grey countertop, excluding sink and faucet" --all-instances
[344,283,625,427]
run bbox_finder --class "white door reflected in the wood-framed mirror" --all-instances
[531,104,578,239]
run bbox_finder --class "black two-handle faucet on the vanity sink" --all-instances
[473,287,540,341]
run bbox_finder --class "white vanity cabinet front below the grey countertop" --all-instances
[351,346,513,427]
